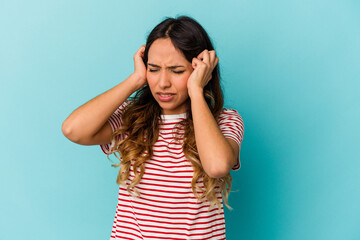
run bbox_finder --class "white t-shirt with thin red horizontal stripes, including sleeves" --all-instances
[100,101,244,240]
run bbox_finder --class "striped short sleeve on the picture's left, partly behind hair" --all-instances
[100,101,130,155]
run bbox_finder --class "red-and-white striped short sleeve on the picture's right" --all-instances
[218,109,244,171]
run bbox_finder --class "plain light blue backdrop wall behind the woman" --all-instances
[0,0,360,240]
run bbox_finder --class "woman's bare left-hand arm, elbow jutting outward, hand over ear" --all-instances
[62,46,146,145]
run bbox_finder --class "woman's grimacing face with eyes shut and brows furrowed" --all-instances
[147,38,193,115]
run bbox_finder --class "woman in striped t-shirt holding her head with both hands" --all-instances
[62,16,244,239]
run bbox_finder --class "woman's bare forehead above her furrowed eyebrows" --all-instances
[148,38,190,65]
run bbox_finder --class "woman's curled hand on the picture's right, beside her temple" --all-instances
[187,49,219,98]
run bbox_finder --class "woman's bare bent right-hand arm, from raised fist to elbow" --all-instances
[187,50,240,178]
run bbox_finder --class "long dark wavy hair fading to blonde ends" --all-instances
[105,16,232,211]
